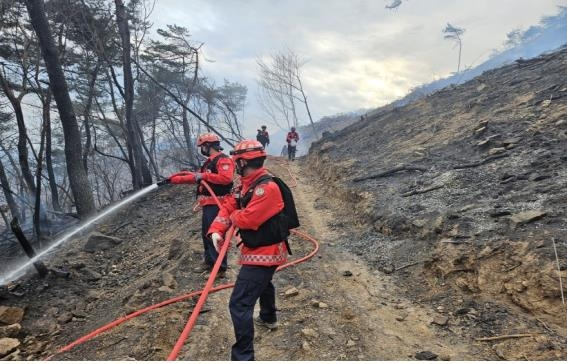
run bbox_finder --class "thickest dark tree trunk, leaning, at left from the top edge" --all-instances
[25,0,96,217]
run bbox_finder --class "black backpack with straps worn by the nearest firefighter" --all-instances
[239,175,300,254]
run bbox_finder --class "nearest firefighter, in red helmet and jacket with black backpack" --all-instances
[209,140,289,360]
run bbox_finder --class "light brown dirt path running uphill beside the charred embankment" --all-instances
[222,158,479,360]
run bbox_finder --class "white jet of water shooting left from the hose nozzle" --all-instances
[0,185,160,286]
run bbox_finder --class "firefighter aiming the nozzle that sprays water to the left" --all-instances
[169,133,234,277]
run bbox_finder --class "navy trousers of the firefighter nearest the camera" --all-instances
[229,265,277,360]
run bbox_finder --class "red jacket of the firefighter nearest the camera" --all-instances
[208,168,288,266]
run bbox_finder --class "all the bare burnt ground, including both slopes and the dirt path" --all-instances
[0,47,567,360]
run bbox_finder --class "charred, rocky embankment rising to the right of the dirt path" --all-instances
[306,49,567,359]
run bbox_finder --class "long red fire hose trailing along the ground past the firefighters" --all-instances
[44,167,319,360]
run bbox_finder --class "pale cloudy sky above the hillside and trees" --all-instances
[150,0,567,137]
